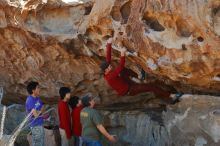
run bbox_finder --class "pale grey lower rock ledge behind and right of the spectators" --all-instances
[0,95,220,146]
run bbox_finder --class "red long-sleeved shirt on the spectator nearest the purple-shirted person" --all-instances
[58,100,72,139]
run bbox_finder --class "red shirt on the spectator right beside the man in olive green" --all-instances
[71,106,83,137]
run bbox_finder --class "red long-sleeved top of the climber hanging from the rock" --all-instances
[104,44,129,96]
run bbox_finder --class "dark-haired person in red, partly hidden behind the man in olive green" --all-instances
[69,96,83,146]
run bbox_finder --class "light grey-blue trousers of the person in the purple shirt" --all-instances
[31,126,45,146]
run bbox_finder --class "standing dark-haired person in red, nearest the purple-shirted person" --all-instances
[58,87,72,146]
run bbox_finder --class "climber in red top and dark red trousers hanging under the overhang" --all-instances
[100,38,183,104]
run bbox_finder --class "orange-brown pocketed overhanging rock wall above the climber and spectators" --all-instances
[0,0,220,103]
